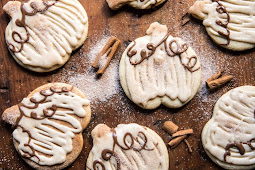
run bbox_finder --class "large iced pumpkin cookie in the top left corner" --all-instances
[3,0,88,72]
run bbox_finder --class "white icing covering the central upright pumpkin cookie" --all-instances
[124,23,200,106]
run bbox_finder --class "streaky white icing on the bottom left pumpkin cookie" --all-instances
[13,90,89,165]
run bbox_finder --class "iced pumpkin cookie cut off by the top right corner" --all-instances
[189,0,255,51]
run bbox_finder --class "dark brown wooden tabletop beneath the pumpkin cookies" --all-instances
[0,0,255,169]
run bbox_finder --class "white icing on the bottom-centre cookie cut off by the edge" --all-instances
[89,124,168,170]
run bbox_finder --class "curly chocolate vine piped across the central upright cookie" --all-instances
[127,34,200,72]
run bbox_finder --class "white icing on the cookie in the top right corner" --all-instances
[188,0,255,44]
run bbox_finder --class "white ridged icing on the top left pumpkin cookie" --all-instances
[6,0,88,68]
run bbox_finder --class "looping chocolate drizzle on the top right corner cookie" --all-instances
[213,0,230,45]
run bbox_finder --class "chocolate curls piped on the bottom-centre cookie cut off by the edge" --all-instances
[93,129,155,170]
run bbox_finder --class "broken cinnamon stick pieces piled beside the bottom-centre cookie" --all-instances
[162,121,193,152]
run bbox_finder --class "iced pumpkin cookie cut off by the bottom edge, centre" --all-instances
[87,123,169,170]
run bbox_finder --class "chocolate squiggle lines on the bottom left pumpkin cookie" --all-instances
[16,86,73,161]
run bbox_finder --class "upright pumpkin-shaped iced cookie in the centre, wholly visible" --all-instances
[119,22,201,109]
